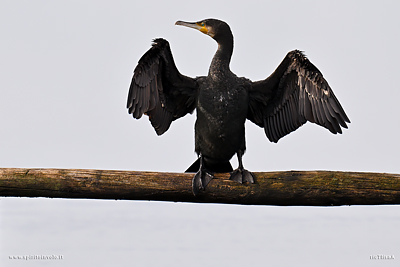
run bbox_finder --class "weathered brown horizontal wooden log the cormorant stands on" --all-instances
[0,168,400,206]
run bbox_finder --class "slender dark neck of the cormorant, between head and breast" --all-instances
[209,35,233,75]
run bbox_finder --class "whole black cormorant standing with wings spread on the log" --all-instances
[127,19,350,195]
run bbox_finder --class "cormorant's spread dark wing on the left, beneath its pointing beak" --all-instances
[127,38,198,135]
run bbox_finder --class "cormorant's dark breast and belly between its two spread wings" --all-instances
[195,78,249,160]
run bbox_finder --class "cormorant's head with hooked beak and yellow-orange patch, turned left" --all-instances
[175,19,232,42]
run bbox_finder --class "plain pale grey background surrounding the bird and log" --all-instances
[0,0,400,266]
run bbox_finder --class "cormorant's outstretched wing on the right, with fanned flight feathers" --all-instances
[247,50,350,143]
